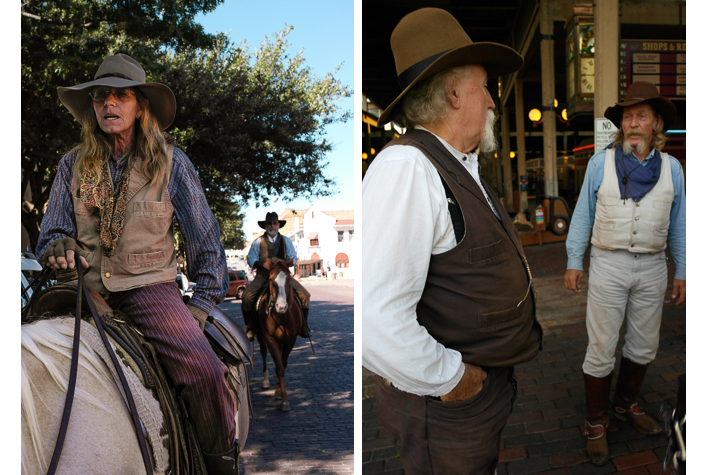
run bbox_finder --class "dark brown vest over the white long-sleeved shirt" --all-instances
[387,129,542,366]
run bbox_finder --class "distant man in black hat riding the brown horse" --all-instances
[242,212,311,340]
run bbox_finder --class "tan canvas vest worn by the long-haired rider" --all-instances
[71,145,177,297]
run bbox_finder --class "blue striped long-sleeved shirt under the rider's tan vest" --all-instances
[35,147,229,313]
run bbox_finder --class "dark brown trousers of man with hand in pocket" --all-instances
[377,367,517,475]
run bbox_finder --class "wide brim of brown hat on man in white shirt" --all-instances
[377,41,524,127]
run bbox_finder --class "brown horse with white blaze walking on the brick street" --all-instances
[256,259,303,411]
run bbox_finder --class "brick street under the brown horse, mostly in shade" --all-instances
[220,279,354,474]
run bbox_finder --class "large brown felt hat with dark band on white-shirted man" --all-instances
[377,8,523,127]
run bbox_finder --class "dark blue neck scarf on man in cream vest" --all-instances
[614,145,661,203]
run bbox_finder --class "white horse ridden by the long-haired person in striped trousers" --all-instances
[21,317,249,475]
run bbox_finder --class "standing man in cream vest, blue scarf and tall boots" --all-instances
[565,81,685,465]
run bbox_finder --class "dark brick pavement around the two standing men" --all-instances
[362,242,685,475]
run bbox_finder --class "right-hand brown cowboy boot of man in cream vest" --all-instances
[614,358,661,435]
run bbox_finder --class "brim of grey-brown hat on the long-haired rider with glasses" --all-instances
[58,77,177,130]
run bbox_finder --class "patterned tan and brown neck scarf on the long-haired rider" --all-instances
[79,154,136,257]
